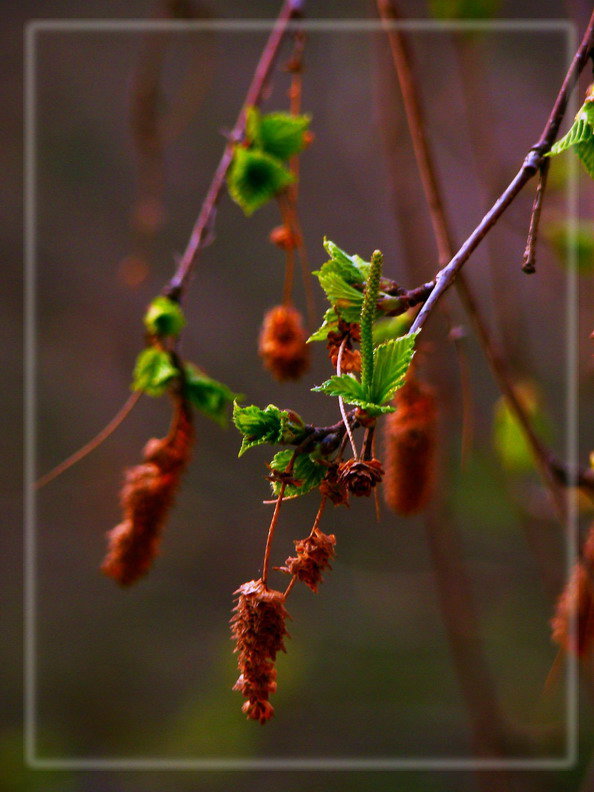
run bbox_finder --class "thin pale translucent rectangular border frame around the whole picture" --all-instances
[23,19,579,771]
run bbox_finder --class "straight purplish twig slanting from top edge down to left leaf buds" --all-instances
[163,0,304,300]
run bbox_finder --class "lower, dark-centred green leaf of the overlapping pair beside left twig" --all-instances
[227,146,294,216]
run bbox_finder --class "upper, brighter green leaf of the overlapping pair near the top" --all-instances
[246,107,311,160]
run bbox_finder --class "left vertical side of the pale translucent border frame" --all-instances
[23,25,37,765]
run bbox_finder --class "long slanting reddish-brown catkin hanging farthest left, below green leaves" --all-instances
[101,404,193,586]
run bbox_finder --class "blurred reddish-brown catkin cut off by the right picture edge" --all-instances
[551,524,594,656]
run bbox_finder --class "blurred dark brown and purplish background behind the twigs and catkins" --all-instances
[0,0,594,792]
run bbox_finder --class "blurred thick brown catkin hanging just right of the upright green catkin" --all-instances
[384,376,437,515]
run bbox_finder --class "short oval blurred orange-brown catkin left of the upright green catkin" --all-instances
[258,305,309,382]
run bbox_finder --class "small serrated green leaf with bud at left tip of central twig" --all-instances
[233,402,305,456]
